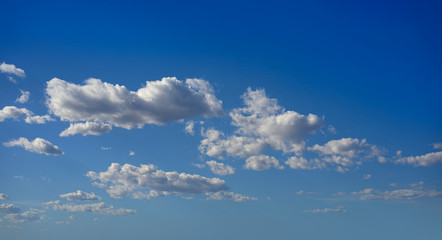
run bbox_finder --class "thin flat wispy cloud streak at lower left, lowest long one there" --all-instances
[43,201,137,216]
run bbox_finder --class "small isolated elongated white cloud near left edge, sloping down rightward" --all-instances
[3,137,64,155]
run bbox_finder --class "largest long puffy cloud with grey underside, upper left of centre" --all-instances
[46,77,224,129]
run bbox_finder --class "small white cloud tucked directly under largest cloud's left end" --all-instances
[60,122,112,137]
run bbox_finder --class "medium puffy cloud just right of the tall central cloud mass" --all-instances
[308,138,383,169]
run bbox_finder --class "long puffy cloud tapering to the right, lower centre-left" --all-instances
[87,163,227,198]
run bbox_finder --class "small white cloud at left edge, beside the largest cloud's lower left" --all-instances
[0,106,54,124]
